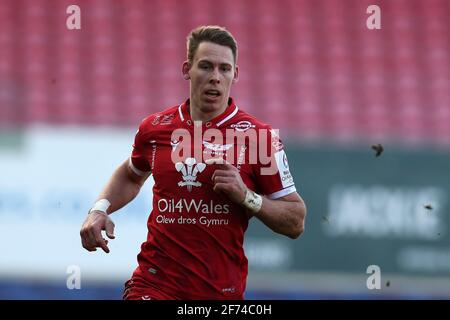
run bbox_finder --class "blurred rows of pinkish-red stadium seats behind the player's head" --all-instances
[0,0,450,145]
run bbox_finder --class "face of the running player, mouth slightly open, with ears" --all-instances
[183,42,238,113]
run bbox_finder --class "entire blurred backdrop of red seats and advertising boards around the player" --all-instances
[0,0,450,299]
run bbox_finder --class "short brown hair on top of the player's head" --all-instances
[187,26,238,65]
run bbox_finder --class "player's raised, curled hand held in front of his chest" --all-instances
[205,159,247,204]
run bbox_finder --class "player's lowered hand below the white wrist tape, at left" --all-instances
[80,210,115,253]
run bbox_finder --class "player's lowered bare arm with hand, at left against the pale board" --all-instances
[80,160,150,253]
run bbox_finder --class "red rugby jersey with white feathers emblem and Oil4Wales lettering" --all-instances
[130,98,296,299]
